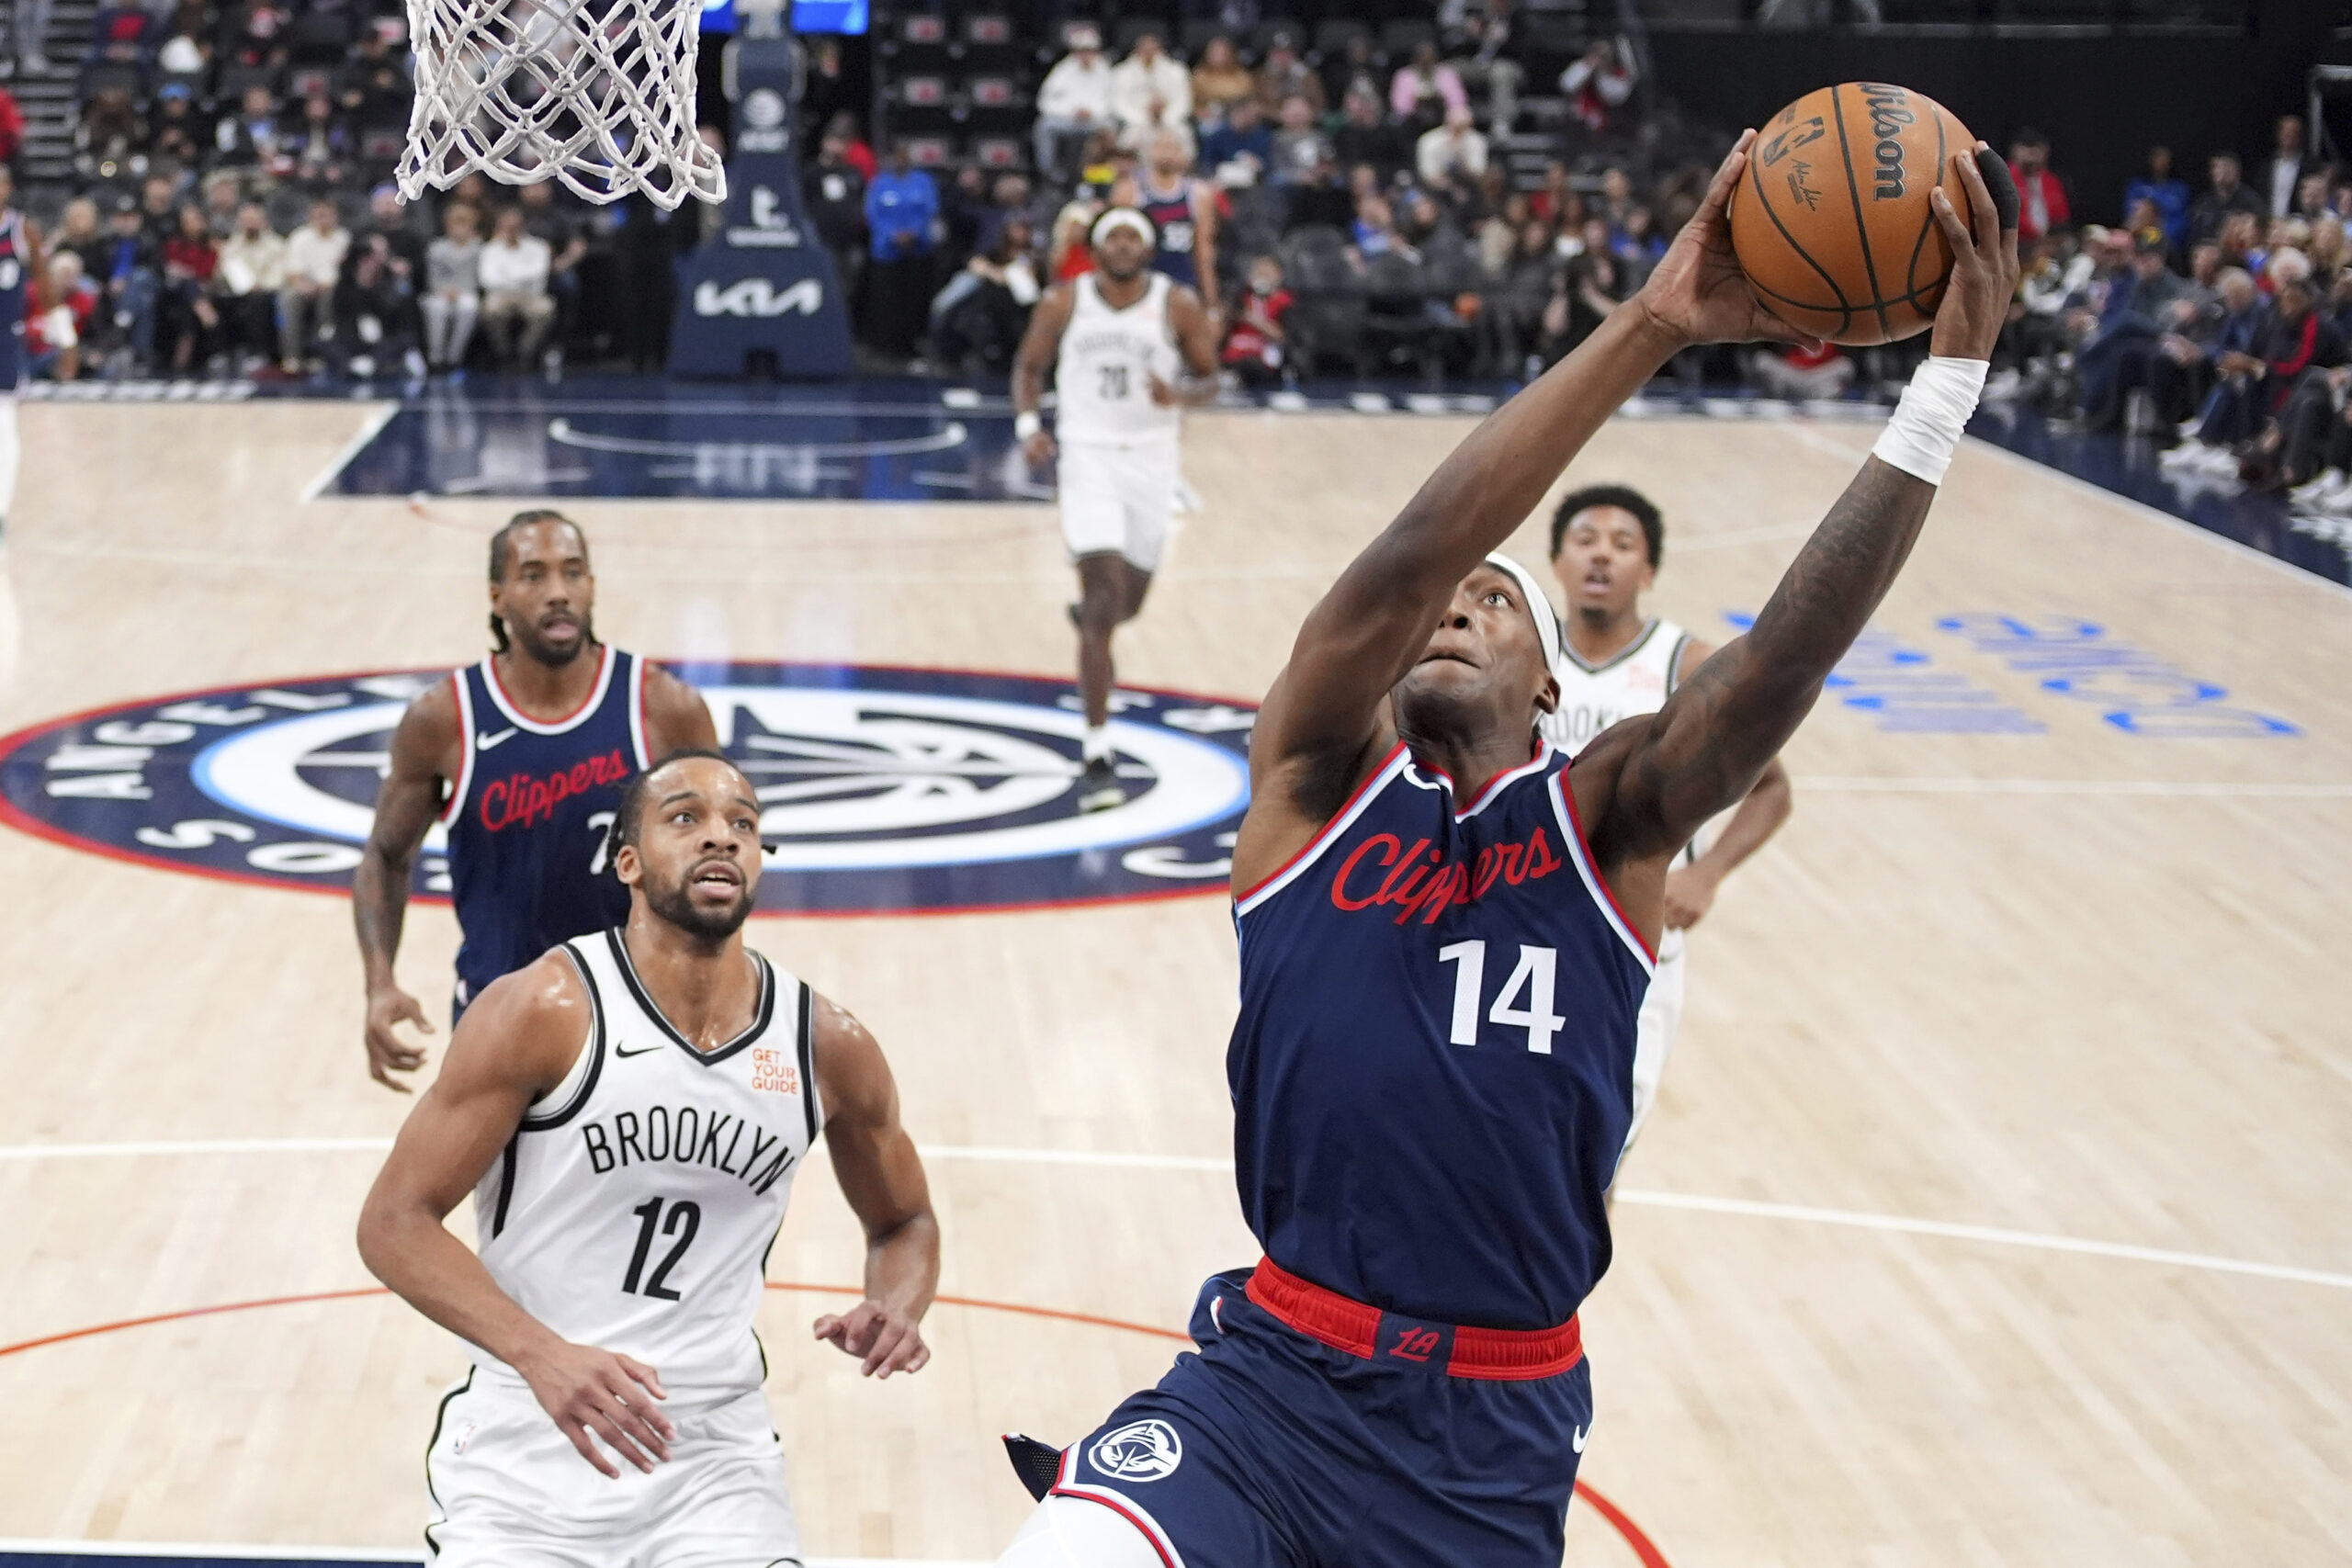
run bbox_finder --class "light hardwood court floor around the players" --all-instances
[0,404,2352,1568]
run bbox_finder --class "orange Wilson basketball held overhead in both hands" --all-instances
[1731,83,1975,344]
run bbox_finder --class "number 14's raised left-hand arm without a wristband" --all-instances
[1235,131,1809,851]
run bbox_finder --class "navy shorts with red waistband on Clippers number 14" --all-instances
[1054,1265,1592,1568]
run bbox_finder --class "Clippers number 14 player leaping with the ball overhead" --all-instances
[1000,134,2018,1568]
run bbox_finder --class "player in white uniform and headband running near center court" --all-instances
[1013,207,1216,811]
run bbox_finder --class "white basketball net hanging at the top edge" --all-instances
[400,0,727,209]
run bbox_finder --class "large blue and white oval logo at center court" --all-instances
[0,663,1256,915]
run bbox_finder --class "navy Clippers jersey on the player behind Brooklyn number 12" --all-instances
[442,647,650,1010]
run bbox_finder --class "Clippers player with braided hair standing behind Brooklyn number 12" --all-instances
[350,510,718,1093]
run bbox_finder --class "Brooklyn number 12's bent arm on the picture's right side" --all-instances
[816,997,938,1378]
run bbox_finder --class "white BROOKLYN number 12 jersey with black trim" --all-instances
[473,929,820,1396]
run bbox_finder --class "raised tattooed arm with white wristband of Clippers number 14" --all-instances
[1571,143,2018,902]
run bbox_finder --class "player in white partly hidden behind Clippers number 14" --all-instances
[1541,484,1790,1166]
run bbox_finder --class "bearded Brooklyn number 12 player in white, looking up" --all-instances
[360,750,938,1568]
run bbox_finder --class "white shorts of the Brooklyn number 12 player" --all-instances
[425,1373,799,1568]
